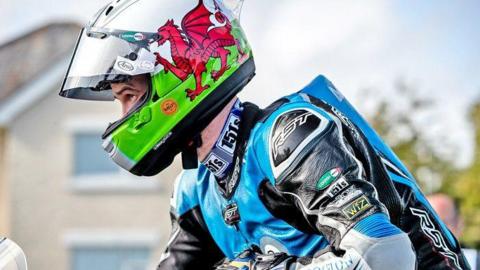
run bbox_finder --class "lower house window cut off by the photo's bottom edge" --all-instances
[71,247,150,270]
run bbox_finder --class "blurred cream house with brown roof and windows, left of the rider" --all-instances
[0,24,178,270]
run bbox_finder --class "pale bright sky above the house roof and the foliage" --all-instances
[0,0,480,165]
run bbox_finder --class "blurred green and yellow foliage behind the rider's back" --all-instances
[369,82,480,248]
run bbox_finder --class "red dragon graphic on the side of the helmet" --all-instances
[155,0,245,101]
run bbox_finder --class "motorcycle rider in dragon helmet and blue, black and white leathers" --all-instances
[60,0,468,269]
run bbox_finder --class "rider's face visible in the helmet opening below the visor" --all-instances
[111,74,147,116]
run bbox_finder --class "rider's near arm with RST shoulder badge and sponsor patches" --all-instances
[261,104,416,269]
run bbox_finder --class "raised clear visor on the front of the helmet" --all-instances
[60,28,159,100]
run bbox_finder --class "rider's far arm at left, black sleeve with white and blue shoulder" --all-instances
[157,173,224,270]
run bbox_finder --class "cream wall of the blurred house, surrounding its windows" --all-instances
[6,89,179,270]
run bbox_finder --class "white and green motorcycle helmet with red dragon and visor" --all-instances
[60,0,255,176]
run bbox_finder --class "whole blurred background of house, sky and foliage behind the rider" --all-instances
[0,0,480,270]
